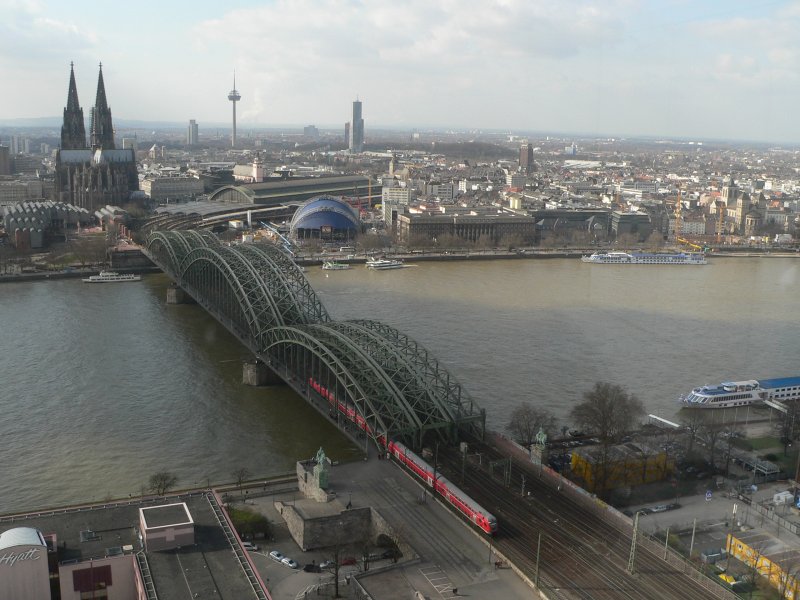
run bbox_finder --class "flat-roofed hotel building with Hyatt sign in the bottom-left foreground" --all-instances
[0,493,269,600]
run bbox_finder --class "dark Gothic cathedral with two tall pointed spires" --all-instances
[56,64,139,211]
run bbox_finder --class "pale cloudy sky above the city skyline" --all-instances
[0,0,800,143]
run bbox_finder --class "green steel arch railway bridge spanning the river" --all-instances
[145,231,485,449]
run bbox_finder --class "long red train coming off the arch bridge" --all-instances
[308,377,497,534]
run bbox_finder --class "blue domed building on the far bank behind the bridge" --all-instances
[290,196,361,241]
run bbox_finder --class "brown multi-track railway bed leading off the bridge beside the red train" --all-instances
[439,440,719,600]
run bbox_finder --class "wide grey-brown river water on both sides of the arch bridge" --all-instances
[0,257,800,512]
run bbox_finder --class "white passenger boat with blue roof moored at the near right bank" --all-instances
[679,377,800,408]
